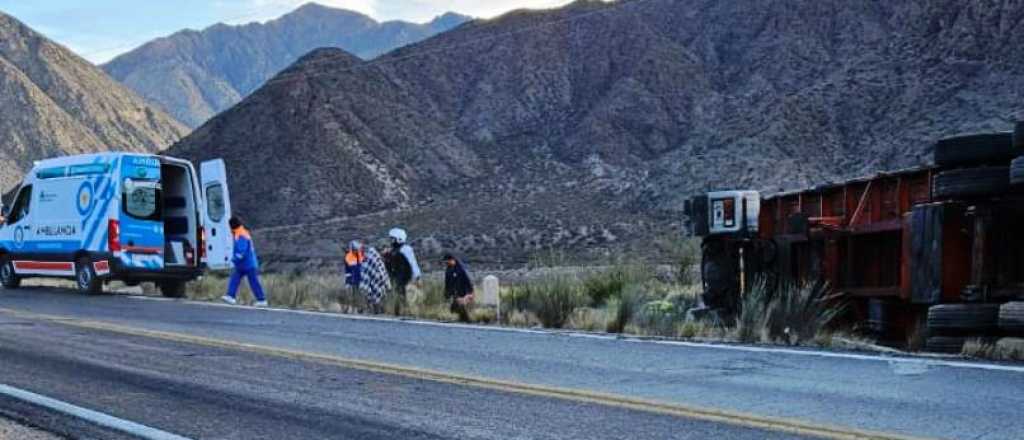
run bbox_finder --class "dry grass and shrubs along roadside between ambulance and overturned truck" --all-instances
[169,235,854,347]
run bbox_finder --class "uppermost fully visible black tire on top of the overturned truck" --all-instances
[935,133,1021,167]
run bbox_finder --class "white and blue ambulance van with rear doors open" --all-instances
[0,152,232,297]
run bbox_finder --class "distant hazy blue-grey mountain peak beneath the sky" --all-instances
[102,3,470,127]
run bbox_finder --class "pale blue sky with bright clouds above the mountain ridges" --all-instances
[0,0,569,64]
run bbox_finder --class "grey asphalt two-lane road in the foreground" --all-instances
[0,289,1024,439]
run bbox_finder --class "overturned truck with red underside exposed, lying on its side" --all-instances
[686,123,1024,352]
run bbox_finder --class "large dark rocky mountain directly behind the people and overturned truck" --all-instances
[173,0,1024,265]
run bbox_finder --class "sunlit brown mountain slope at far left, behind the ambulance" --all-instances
[0,13,188,192]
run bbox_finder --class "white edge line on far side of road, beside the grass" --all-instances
[131,297,1024,373]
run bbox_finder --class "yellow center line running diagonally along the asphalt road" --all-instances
[0,308,928,440]
